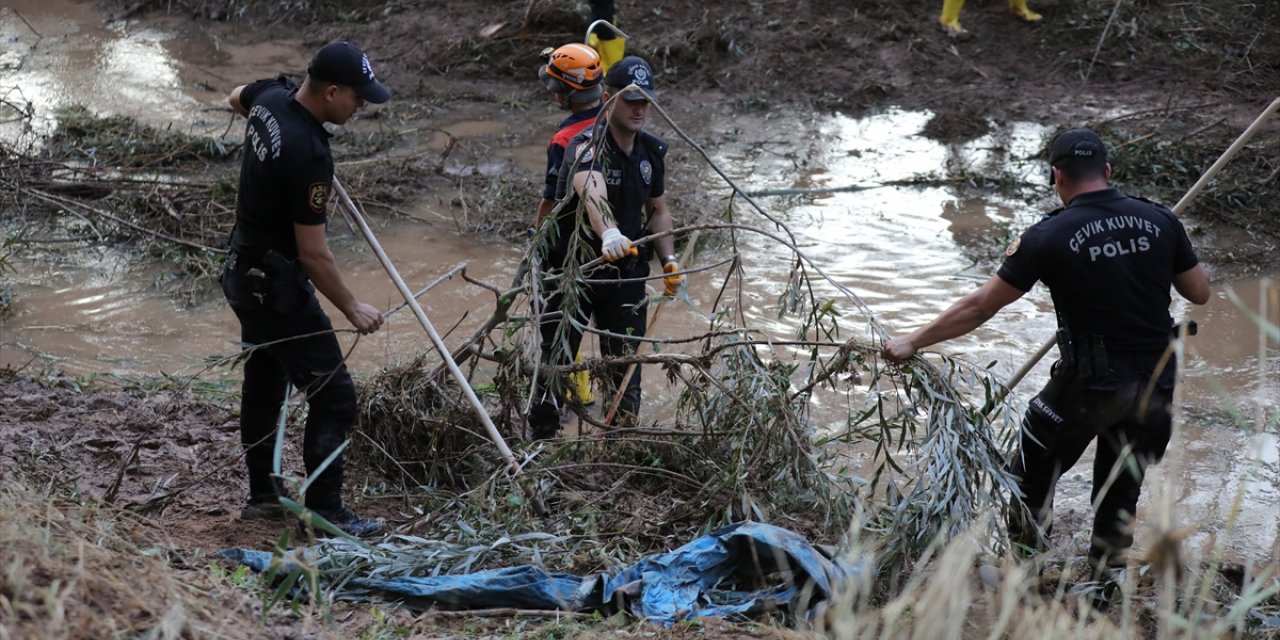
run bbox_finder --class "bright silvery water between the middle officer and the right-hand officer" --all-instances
[708,109,1053,373]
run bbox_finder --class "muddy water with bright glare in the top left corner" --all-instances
[0,0,290,141]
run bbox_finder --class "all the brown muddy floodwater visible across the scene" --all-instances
[0,0,1280,558]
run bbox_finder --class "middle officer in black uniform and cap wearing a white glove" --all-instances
[529,56,684,438]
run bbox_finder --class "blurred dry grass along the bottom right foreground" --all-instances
[813,522,1280,640]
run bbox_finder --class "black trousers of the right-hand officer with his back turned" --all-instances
[1009,353,1176,568]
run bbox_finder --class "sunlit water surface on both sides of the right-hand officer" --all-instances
[719,111,1280,558]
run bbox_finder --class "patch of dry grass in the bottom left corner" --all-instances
[0,475,260,640]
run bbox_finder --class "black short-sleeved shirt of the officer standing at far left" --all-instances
[232,76,333,260]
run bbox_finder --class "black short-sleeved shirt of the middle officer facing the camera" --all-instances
[549,125,667,266]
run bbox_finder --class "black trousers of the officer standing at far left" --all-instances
[221,261,356,509]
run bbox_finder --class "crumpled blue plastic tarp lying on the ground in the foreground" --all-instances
[220,522,865,625]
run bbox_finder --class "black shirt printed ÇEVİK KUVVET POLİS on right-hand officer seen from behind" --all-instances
[997,188,1198,352]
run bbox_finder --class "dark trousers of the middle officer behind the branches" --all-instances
[529,261,649,438]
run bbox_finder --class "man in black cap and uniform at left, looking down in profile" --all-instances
[221,42,390,535]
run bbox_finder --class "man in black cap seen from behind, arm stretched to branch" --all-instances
[883,128,1210,604]
